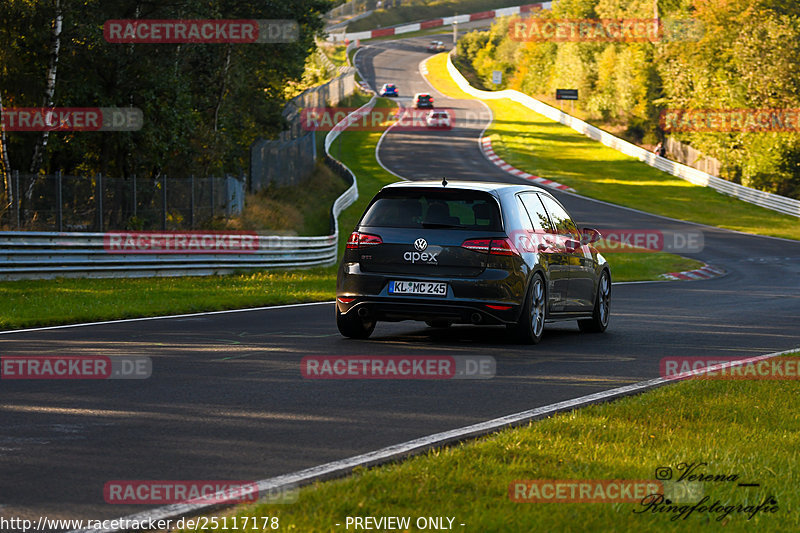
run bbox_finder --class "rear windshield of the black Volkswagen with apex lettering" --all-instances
[361,189,503,231]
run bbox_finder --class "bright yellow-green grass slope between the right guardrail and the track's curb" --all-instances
[428,54,800,239]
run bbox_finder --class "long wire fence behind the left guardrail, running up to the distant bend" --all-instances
[0,68,357,232]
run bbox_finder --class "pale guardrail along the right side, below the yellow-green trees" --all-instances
[447,55,800,217]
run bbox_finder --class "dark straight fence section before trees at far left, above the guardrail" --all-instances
[0,171,244,232]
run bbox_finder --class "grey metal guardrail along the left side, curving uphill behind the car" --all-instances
[0,96,375,280]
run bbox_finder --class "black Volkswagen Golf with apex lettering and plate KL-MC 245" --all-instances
[336,180,611,344]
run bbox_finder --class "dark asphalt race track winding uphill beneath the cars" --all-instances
[0,38,800,519]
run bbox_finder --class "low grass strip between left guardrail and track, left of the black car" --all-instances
[0,267,336,330]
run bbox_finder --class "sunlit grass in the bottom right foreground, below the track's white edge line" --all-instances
[184,354,800,533]
